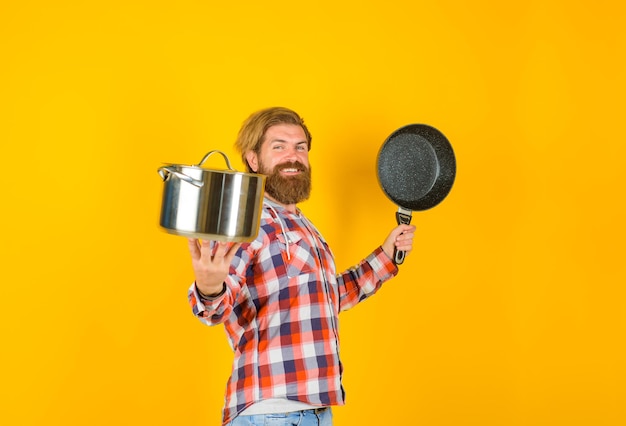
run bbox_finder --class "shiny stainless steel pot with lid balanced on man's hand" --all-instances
[158,150,265,242]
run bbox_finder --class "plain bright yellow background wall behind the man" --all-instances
[0,0,626,426]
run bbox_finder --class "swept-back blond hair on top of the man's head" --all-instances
[235,107,311,172]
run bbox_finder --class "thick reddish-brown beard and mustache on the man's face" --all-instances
[259,161,311,205]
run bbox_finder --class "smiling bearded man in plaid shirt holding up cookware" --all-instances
[188,107,415,426]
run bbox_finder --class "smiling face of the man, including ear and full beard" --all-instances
[248,124,311,205]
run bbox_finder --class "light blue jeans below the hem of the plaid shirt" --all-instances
[227,408,333,426]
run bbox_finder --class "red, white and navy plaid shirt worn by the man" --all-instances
[188,199,398,424]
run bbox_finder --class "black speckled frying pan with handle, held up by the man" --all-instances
[377,124,456,265]
